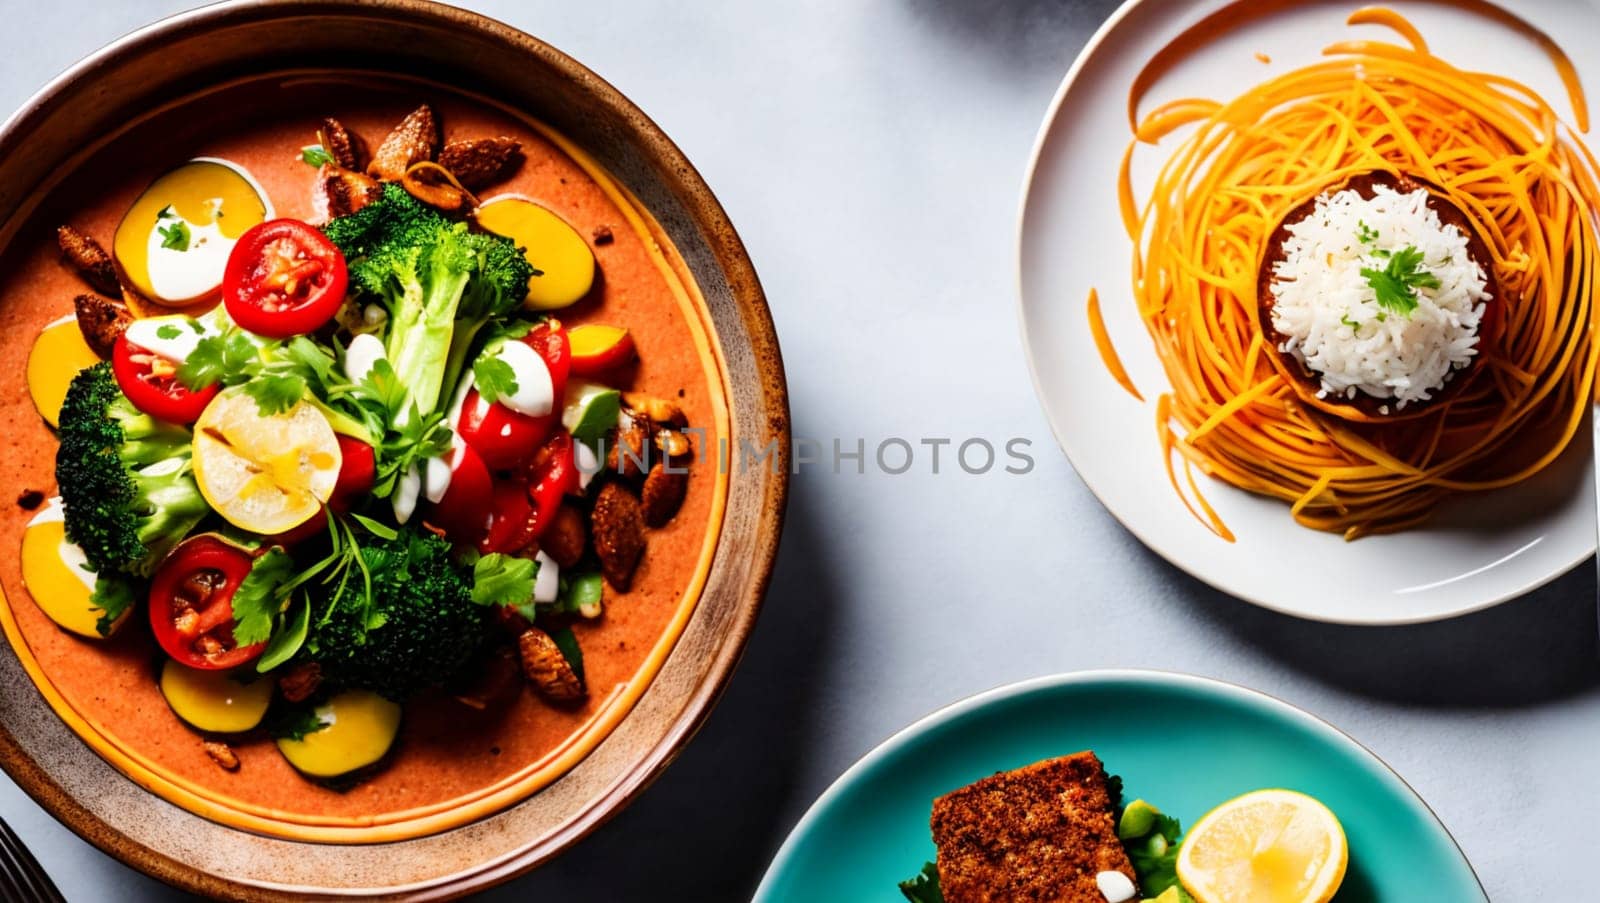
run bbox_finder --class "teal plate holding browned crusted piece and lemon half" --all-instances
[755,671,1488,903]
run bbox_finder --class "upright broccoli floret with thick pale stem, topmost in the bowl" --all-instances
[323,183,533,415]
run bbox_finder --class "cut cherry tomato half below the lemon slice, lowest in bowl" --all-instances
[150,535,267,671]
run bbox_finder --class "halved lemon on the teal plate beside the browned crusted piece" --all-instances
[1178,789,1349,903]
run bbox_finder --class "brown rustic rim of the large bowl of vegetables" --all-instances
[0,0,790,900]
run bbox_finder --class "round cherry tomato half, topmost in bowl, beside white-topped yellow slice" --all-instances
[222,219,349,338]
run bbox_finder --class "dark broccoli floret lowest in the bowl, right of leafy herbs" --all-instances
[301,527,491,700]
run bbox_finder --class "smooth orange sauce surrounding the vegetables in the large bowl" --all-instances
[0,75,730,842]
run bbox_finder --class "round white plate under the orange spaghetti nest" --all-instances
[1019,0,1600,624]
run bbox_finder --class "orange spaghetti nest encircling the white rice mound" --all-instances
[1122,11,1600,538]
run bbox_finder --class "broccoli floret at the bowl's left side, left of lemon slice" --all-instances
[56,363,210,576]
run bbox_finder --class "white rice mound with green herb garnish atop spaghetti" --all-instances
[1270,186,1490,413]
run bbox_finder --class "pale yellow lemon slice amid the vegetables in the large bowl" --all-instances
[194,389,341,533]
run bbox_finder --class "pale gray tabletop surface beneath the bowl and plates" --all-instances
[0,0,1600,901]
